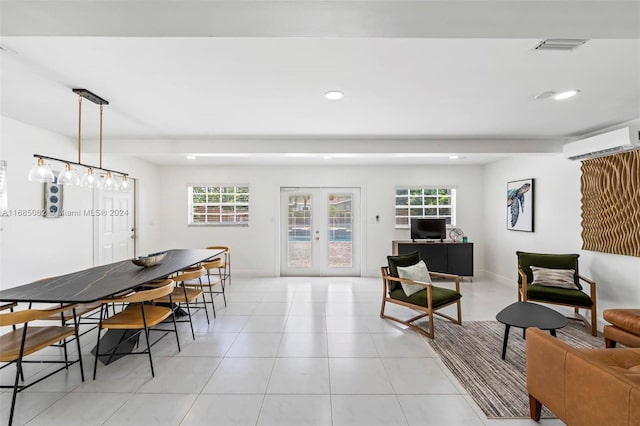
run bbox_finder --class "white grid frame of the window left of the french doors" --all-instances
[187,183,251,226]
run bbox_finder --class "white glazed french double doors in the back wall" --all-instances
[280,188,361,276]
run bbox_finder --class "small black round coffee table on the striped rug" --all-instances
[496,302,569,359]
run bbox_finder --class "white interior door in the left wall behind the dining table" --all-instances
[93,183,135,266]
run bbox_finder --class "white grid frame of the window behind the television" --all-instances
[393,185,457,229]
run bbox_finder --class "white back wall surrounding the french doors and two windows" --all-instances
[161,166,485,276]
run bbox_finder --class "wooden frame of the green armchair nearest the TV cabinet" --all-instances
[380,266,462,339]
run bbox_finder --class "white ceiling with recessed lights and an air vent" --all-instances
[0,0,640,164]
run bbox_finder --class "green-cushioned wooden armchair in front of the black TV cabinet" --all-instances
[380,252,462,339]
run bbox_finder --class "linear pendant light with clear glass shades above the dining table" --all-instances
[29,89,130,192]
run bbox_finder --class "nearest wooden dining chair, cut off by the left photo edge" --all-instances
[0,305,84,425]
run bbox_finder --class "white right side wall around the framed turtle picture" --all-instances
[484,156,640,326]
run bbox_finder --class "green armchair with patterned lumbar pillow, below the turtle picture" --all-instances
[516,251,598,336]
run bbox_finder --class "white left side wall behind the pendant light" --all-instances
[0,116,160,288]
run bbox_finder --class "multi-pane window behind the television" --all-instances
[395,187,456,228]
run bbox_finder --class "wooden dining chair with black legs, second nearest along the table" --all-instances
[93,279,180,380]
